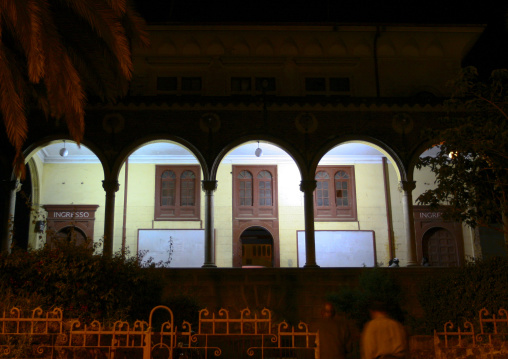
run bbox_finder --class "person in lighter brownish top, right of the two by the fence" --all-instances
[361,302,408,359]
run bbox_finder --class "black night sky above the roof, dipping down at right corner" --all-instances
[134,0,508,74]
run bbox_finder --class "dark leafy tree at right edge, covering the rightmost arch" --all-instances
[416,67,508,249]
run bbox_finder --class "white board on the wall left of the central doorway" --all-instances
[138,229,205,268]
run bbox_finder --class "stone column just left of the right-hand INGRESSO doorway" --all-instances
[399,181,418,267]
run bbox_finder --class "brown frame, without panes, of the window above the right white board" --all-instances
[314,165,358,222]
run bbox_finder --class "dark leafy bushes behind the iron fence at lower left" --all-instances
[0,242,162,321]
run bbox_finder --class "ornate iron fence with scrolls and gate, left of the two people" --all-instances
[0,306,317,359]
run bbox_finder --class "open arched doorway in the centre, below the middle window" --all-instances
[240,226,273,268]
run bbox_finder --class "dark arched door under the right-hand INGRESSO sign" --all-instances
[422,227,459,267]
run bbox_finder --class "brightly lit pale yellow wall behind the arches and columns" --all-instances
[31,155,474,267]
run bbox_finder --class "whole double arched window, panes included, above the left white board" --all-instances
[155,165,201,220]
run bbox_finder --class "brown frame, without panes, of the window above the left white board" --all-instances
[154,165,201,221]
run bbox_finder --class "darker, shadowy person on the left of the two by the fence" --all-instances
[315,302,352,359]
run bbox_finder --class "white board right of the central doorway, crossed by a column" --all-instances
[297,231,376,267]
